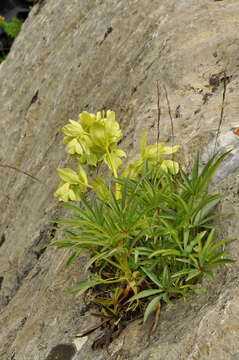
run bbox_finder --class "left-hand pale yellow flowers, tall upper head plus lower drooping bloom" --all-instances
[55,110,126,202]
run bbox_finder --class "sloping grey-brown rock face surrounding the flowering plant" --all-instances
[0,0,239,360]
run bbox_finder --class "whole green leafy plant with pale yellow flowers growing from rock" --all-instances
[51,110,233,330]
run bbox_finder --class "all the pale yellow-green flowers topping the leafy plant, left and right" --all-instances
[54,110,179,202]
